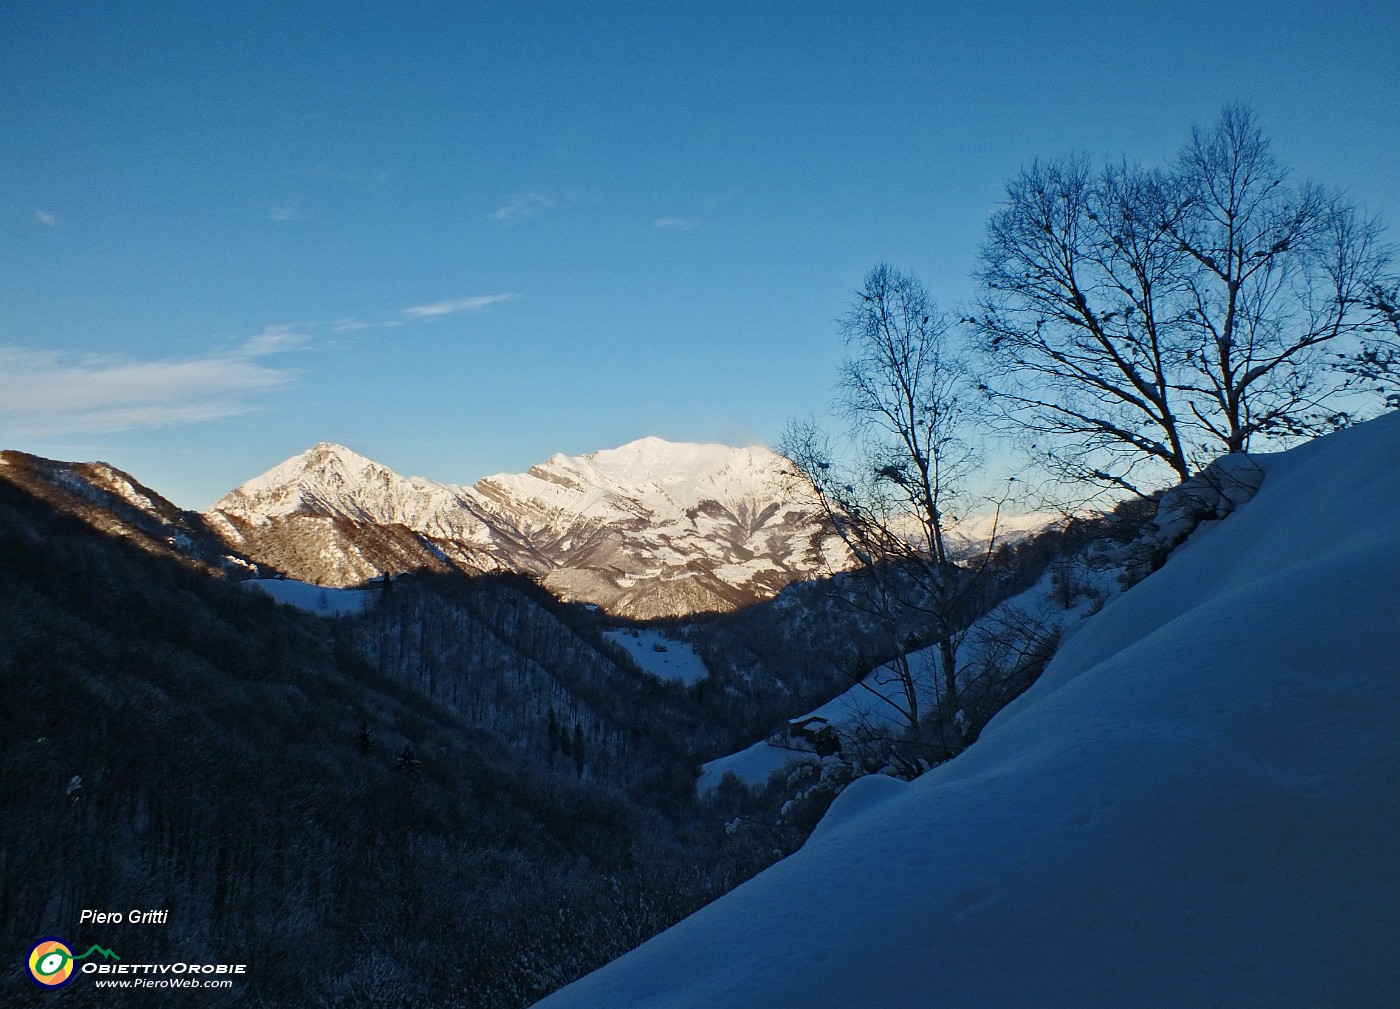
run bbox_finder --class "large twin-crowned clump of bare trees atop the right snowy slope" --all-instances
[970,106,1389,491]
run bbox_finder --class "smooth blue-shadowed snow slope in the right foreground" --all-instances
[529,416,1400,1009]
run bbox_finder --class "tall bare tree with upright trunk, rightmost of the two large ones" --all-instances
[1162,106,1389,452]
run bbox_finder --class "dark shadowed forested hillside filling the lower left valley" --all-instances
[0,479,795,1006]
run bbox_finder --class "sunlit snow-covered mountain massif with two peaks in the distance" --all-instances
[206,438,834,619]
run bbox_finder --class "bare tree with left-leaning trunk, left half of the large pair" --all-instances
[972,158,1190,491]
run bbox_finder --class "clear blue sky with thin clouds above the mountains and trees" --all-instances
[0,0,1400,507]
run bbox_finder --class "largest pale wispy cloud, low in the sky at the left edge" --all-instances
[0,326,305,437]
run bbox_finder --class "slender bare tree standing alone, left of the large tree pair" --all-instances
[781,263,995,755]
